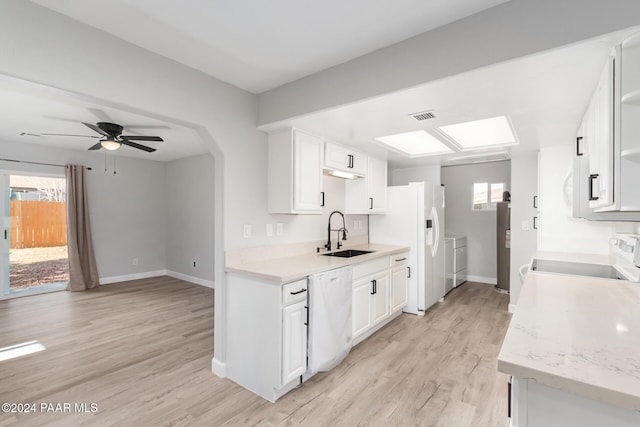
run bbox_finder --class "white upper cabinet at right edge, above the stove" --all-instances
[574,33,640,221]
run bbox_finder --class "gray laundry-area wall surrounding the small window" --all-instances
[441,161,511,283]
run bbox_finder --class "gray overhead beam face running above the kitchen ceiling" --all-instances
[259,0,640,125]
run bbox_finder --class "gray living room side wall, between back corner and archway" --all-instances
[164,154,214,282]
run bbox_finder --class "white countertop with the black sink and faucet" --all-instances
[225,244,409,283]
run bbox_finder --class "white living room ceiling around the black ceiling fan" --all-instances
[0,76,208,161]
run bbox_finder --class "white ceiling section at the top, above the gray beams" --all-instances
[33,0,507,93]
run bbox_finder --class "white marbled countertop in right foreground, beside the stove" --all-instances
[498,272,640,411]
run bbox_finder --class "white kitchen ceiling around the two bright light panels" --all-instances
[261,30,632,167]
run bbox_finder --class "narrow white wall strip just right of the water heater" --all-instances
[510,152,540,304]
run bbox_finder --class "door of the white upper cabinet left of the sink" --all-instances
[293,131,324,213]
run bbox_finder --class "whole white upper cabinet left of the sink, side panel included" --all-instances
[267,129,324,214]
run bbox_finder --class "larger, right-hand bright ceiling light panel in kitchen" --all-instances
[438,116,517,149]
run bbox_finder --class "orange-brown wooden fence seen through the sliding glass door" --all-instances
[9,200,67,249]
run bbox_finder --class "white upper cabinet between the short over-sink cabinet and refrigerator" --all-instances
[345,157,387,215]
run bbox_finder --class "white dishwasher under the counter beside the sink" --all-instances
[307,266,353,375]
